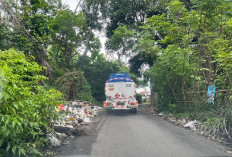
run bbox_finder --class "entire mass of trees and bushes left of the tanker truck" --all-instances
[0,0,137,157]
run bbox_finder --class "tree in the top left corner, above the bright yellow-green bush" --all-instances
[0,0,59,78]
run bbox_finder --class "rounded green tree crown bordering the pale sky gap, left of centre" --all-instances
[48,10,101,69]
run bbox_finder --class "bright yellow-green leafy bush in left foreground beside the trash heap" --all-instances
[0,49,62,156]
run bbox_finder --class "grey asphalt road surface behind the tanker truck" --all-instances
[57,111,231,157]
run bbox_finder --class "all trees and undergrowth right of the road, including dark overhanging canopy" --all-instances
[83,0,232,144]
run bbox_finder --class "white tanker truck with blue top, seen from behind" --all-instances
[103,73,138,113]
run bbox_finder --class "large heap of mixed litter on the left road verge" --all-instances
[47,101,102,147]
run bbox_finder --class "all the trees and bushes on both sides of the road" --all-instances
[0,0,232,156]
